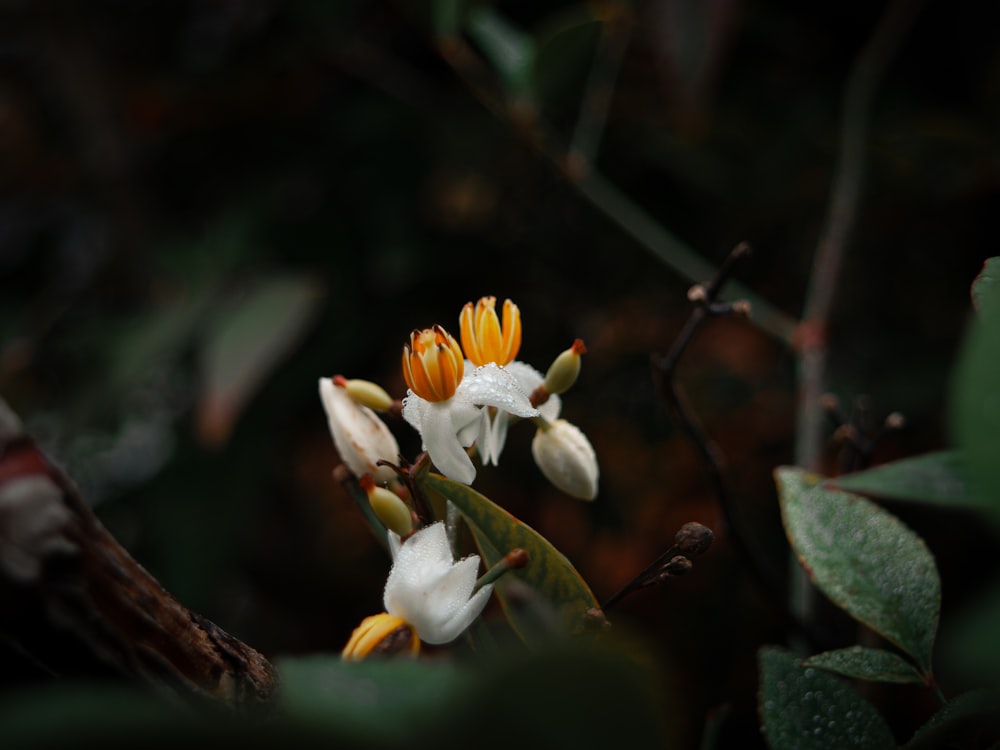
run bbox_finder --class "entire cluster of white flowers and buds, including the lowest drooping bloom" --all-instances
[319,297,598,659]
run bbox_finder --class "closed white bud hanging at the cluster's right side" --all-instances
[531,419,598,500]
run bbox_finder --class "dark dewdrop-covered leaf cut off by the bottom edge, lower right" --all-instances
[758,646,896,750]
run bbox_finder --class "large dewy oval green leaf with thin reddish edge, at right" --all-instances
[775,467,941,675]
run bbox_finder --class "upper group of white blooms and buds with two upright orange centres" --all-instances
[320,297,598,500]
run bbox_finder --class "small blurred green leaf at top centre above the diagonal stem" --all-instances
[466,4,536,101]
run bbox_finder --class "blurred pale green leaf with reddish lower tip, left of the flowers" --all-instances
[197,275,323,446]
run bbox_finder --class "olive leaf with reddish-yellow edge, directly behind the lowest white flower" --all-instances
[417,472,600,639]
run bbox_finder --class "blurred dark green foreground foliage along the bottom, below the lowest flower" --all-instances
[276,639,664,748]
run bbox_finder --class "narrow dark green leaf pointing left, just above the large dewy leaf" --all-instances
[827,451,976,507]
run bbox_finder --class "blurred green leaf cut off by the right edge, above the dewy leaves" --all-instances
[949,294,1000,524]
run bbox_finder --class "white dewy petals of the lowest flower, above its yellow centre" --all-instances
[383,521,493,644]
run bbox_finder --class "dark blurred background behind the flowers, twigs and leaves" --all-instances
[0,0,1000,747]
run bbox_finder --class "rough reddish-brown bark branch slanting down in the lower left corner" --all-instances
[0,399,277,710]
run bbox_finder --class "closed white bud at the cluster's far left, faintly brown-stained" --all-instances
[319,378,399,483]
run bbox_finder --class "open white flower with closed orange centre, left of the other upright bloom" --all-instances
[403,326,539,484]
